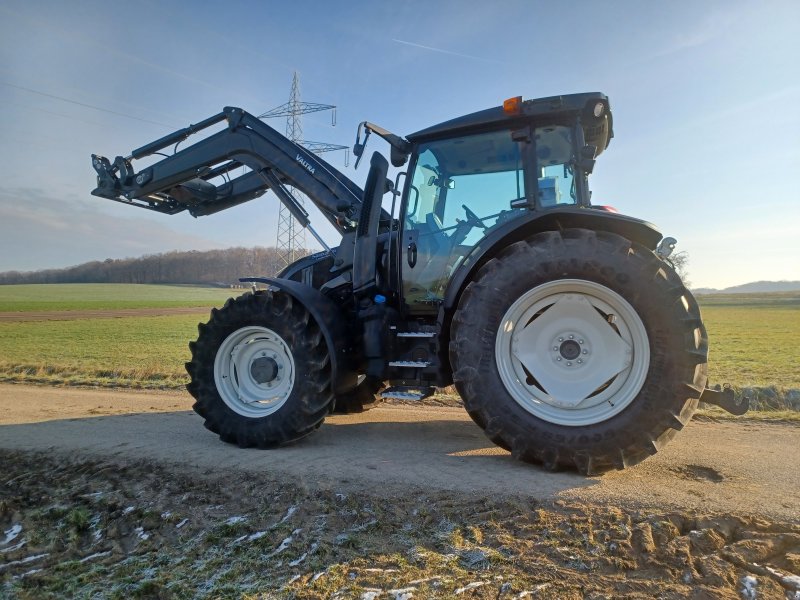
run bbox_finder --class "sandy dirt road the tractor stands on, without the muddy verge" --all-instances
[0,385,800,521]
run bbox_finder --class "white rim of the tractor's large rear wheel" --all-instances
[495,279,650,426]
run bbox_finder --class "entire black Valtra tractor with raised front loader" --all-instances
[92,93,747,474]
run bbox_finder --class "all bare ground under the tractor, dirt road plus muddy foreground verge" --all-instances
[0,385,800,600]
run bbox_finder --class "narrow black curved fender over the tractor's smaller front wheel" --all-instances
[239,277,358,395]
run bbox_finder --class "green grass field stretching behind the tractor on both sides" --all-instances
[0,285,800,395]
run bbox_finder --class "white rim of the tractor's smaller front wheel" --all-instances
[214,326,295,418]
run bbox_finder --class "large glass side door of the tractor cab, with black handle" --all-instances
[400,129,526,316]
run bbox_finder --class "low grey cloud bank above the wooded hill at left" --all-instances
[0,188,219,272]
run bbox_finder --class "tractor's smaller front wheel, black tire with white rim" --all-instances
[186,291,333,448]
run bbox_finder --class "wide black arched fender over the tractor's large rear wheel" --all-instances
[444,206,662,311]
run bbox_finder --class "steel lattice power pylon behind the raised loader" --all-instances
[258,71,349,267]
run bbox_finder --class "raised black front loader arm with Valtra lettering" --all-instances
[92,107,382,234]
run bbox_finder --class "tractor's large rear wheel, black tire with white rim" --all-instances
[450,229,708,474]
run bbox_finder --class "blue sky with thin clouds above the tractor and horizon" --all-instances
[0,0,800,288]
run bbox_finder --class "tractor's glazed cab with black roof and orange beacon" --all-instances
[366,93,613,315]
